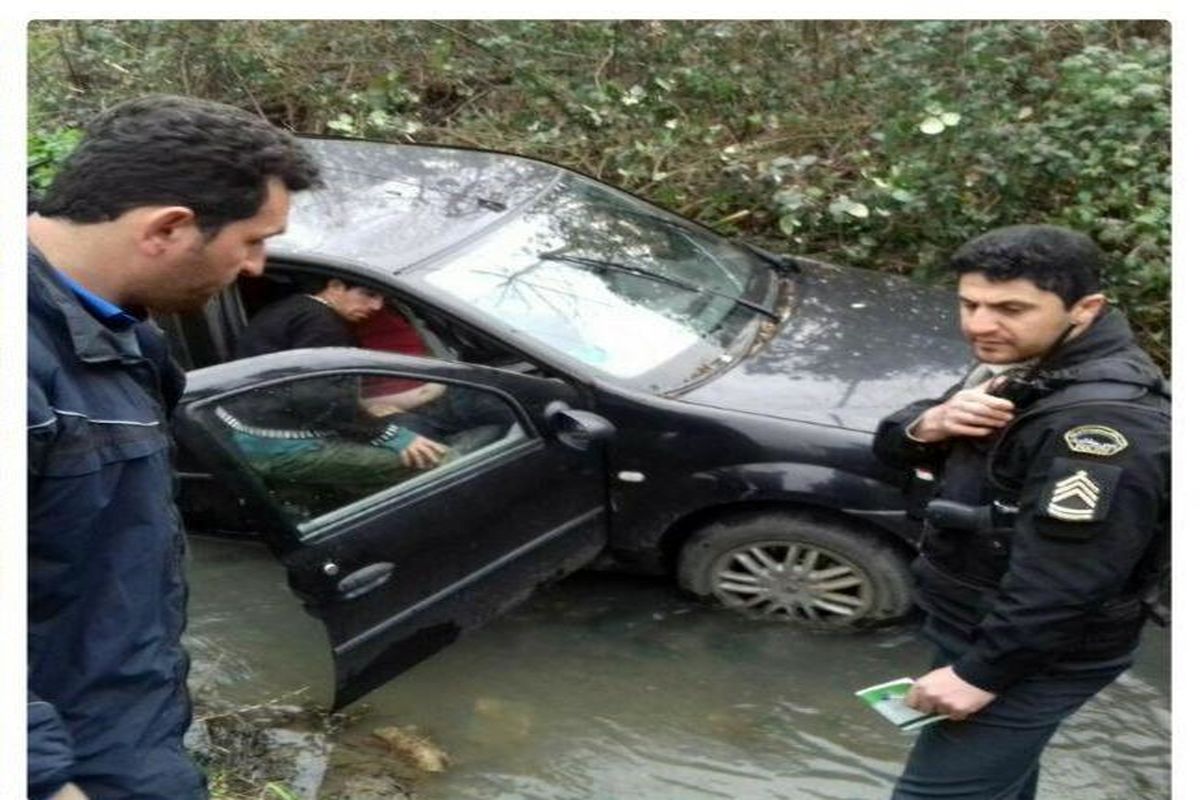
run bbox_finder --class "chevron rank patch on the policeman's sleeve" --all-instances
[1038,458,1121,539]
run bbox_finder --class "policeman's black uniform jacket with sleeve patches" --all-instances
[875,312,1170,691]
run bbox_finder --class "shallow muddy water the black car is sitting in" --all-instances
[190,541,1170,800]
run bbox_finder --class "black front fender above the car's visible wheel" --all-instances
[585,385,917,573]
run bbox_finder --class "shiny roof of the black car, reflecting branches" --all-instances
[271,137,566,273]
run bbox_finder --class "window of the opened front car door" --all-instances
[190,372,529,535]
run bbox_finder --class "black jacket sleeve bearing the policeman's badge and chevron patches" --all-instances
[954,405,1170,692]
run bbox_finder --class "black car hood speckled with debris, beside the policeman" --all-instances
[678,263,971,431]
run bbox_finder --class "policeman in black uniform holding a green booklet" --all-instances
[875,225,1170,800]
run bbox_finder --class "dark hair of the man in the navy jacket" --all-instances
[37,95,320,236]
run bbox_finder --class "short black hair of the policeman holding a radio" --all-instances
[947,225,1103,308]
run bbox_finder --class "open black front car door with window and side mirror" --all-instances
[175,348,611,709]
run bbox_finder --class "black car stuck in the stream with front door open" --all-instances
[160,139,968,706]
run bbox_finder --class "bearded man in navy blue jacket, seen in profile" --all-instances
[28,96,318,800]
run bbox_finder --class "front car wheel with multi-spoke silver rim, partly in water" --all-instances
[678,512,913,630]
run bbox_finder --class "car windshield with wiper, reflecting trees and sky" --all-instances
[421,174,773,391]
